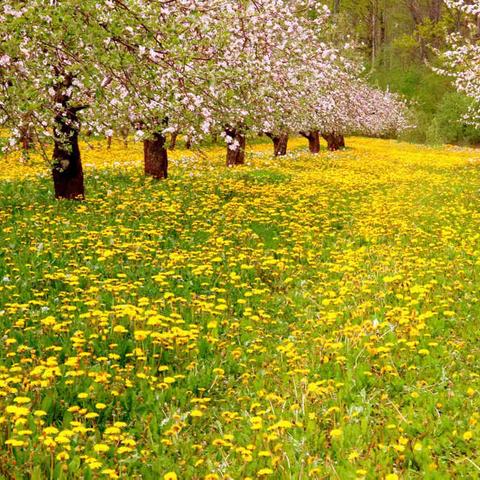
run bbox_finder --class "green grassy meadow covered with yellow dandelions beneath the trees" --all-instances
[0,139,480,480]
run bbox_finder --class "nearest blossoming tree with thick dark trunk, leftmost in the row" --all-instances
[0,0,109,198]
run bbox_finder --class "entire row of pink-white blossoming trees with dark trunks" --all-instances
[0,0,407,198]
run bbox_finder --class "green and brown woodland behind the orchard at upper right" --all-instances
[330,0,480,145]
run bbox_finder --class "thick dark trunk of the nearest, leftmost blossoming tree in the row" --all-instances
[52,108,85,200]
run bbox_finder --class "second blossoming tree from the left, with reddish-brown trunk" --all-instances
[87,0,223,178]
